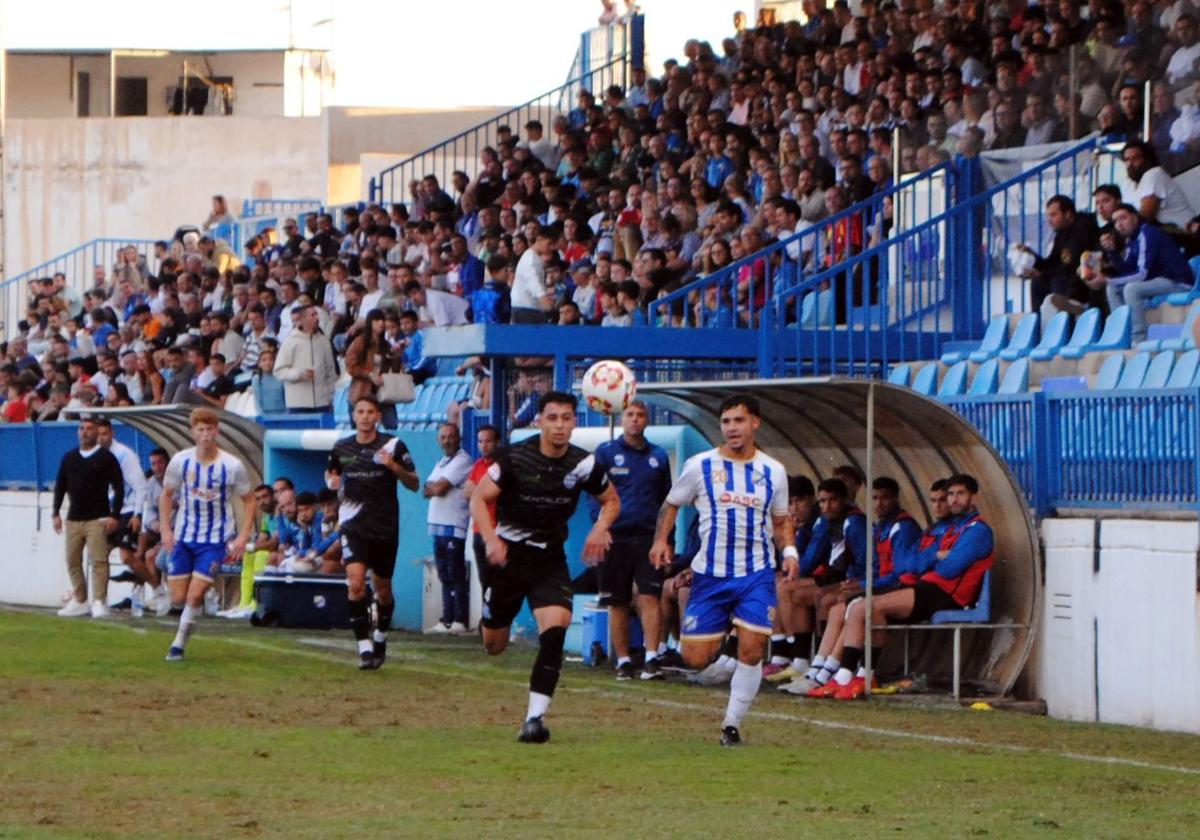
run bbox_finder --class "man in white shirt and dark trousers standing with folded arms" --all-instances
[422,422,474,634]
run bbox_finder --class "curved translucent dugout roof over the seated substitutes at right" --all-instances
[638,378,1040,694]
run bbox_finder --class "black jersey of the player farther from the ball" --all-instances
[328,432,414,540]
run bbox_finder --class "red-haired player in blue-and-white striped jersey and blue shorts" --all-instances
[158,408,256,662]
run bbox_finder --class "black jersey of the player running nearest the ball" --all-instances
[487,436,608,548]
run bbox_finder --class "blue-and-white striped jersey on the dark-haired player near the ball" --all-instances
[667,449,787,577]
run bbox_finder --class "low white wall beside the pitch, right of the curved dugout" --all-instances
[1038,520,1200,732]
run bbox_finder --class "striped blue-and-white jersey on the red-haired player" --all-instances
[162,446,251,545]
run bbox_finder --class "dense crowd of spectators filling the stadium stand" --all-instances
[7,0,1200,421]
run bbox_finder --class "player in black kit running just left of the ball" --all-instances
[470,391,620,744]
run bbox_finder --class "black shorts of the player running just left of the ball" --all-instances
[479,540,574,630]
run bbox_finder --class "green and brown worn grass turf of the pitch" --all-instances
[0,611,1200,839]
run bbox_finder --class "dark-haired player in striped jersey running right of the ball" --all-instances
[650,396,799,746]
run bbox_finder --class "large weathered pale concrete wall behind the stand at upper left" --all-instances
[4,116,325,274]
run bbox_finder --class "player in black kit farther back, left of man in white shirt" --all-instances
[325,396,420,671]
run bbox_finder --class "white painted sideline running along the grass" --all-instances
[25,609,1200,776]
